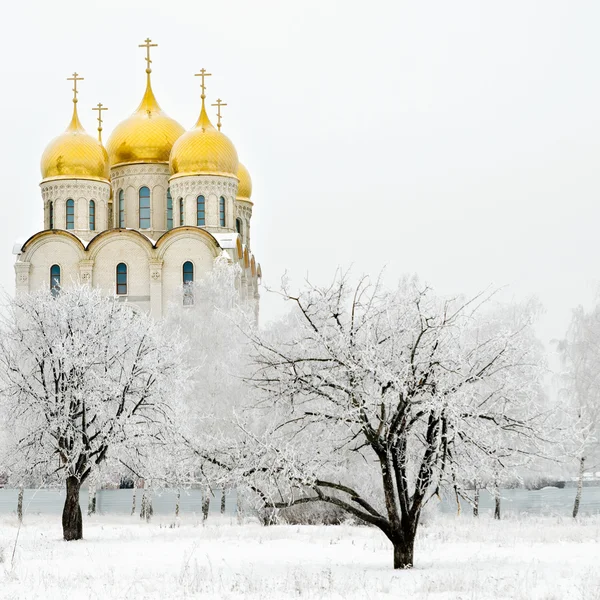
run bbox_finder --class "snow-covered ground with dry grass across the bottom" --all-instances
[0,510,600,600]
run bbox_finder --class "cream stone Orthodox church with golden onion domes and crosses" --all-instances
[15,39,261,318]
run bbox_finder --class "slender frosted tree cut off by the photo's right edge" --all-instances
[558,305,600,517]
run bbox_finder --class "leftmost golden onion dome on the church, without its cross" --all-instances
[40,100,108,181]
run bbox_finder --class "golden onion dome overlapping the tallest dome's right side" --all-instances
[170,96,238,177]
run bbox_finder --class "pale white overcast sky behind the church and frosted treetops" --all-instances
[0,0,600,339]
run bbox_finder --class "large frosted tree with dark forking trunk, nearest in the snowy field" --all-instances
[236,275,546,568]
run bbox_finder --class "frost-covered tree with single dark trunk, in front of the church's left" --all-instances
[0,286,185,540]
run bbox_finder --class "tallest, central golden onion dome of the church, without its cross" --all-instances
[106,76,185,167]
